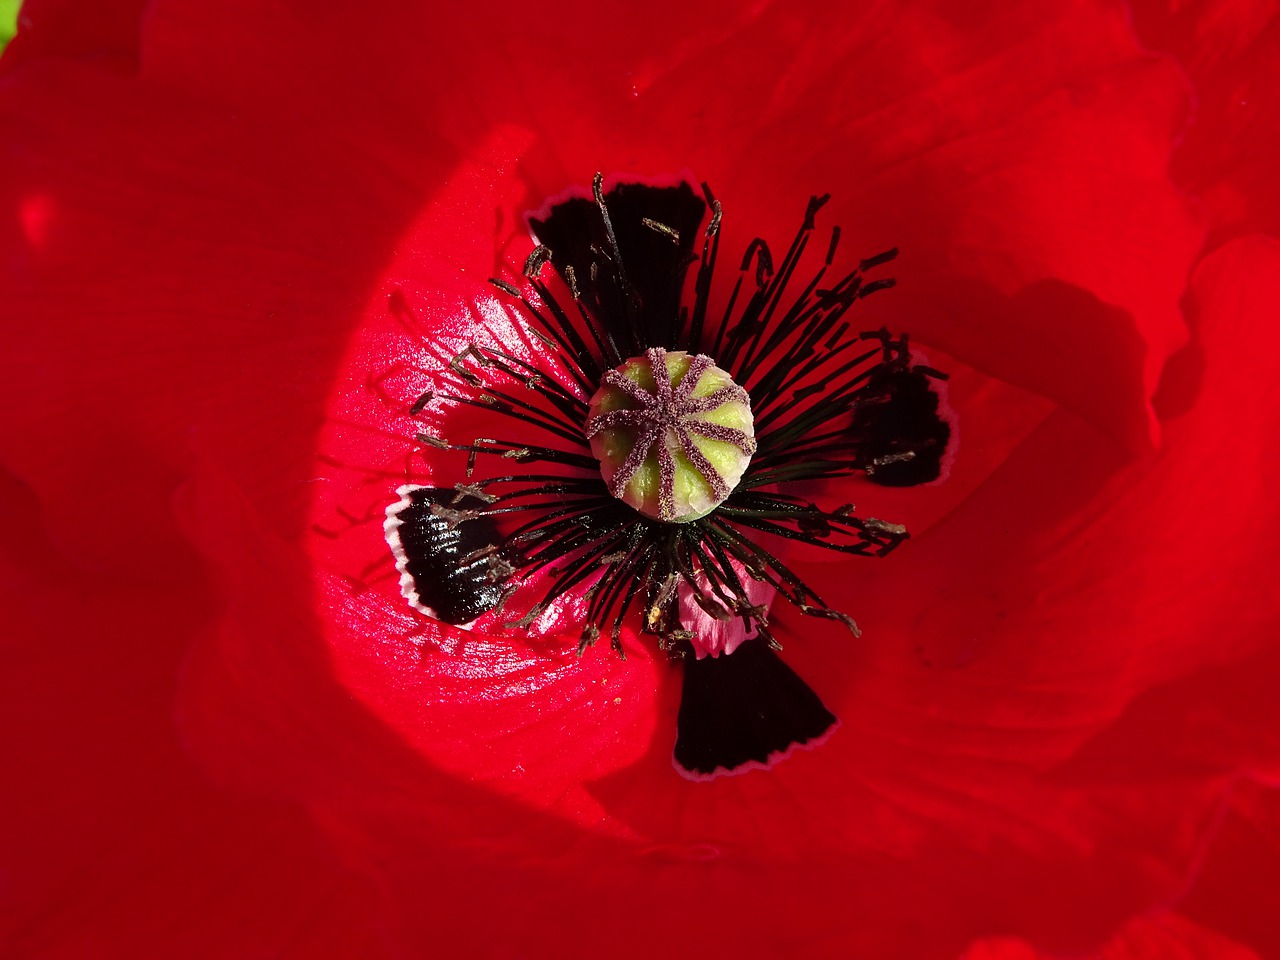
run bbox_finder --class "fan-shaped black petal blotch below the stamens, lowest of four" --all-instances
[676,640,836,776]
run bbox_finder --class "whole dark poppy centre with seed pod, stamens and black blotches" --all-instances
[371,175,952,780]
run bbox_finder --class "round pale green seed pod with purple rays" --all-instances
[585,347,755,524]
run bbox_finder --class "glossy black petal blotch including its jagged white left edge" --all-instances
[384,486,507,625]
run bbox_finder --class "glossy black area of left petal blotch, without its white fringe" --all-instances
[397,486,503,623]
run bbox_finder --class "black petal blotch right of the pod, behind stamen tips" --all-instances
[850,365,951,486]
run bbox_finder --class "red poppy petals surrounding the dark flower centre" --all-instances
[0,0,1280,957]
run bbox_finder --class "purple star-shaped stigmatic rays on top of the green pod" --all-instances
[586,347,755,522]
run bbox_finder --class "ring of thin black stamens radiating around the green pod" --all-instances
[389,178,945,654]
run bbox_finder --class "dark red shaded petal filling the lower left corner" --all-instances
[0,472,381,960]
